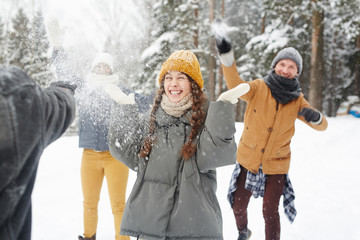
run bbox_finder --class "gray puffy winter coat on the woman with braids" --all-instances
[109,98,236,240]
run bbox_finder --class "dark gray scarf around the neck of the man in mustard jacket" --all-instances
[264,70,301,104]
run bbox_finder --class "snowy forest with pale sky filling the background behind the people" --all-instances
[0,0,360,121]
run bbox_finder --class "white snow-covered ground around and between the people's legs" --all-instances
[32,116,360,240]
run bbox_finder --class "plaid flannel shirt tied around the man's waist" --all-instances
[227,163,296,223]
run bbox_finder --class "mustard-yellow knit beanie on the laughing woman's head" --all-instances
[159,50,204,88]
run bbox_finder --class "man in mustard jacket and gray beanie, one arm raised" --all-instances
[216,37,327,240]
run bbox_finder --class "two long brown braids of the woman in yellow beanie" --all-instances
[139,73,206,160]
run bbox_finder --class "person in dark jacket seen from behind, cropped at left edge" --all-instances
[0,65,75,240]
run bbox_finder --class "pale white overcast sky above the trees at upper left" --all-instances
[0,0,145,50]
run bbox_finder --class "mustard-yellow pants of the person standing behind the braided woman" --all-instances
[81,149,130,240]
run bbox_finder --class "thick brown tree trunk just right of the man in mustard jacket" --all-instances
[309,0,324,111]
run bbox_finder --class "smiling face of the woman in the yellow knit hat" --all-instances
[164,71,191,103]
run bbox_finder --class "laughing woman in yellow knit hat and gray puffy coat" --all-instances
[108,50,248,240]
